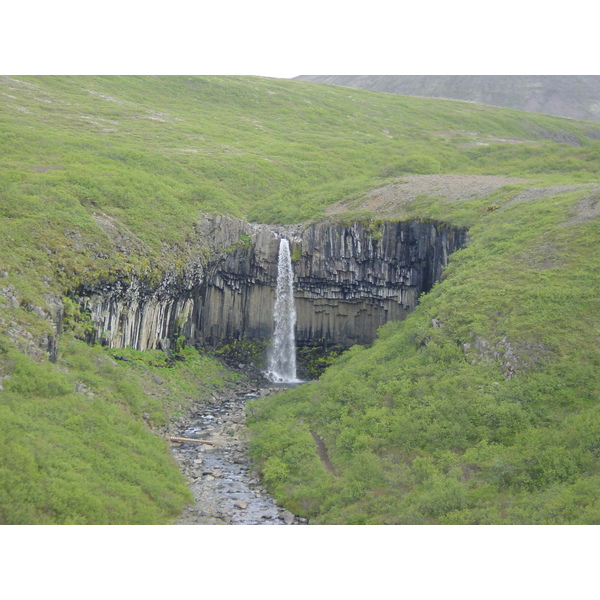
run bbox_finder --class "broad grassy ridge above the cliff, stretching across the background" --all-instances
[0,76,600,305]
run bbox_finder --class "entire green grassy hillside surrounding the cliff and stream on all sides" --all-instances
[0,77,600,523]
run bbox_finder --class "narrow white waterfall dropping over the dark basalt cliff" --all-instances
[266,238,299,383]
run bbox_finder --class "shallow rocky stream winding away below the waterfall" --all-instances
[170,388,308,525]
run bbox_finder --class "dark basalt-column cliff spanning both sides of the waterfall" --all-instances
[80,216,466,350]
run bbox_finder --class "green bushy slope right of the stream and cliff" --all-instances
[247,182,600,524]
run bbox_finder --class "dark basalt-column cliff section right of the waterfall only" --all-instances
[296,223,465,346]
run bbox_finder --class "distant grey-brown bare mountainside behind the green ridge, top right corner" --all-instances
[295,75,600,121]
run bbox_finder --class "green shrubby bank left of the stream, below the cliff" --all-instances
[0,336,231,524]
